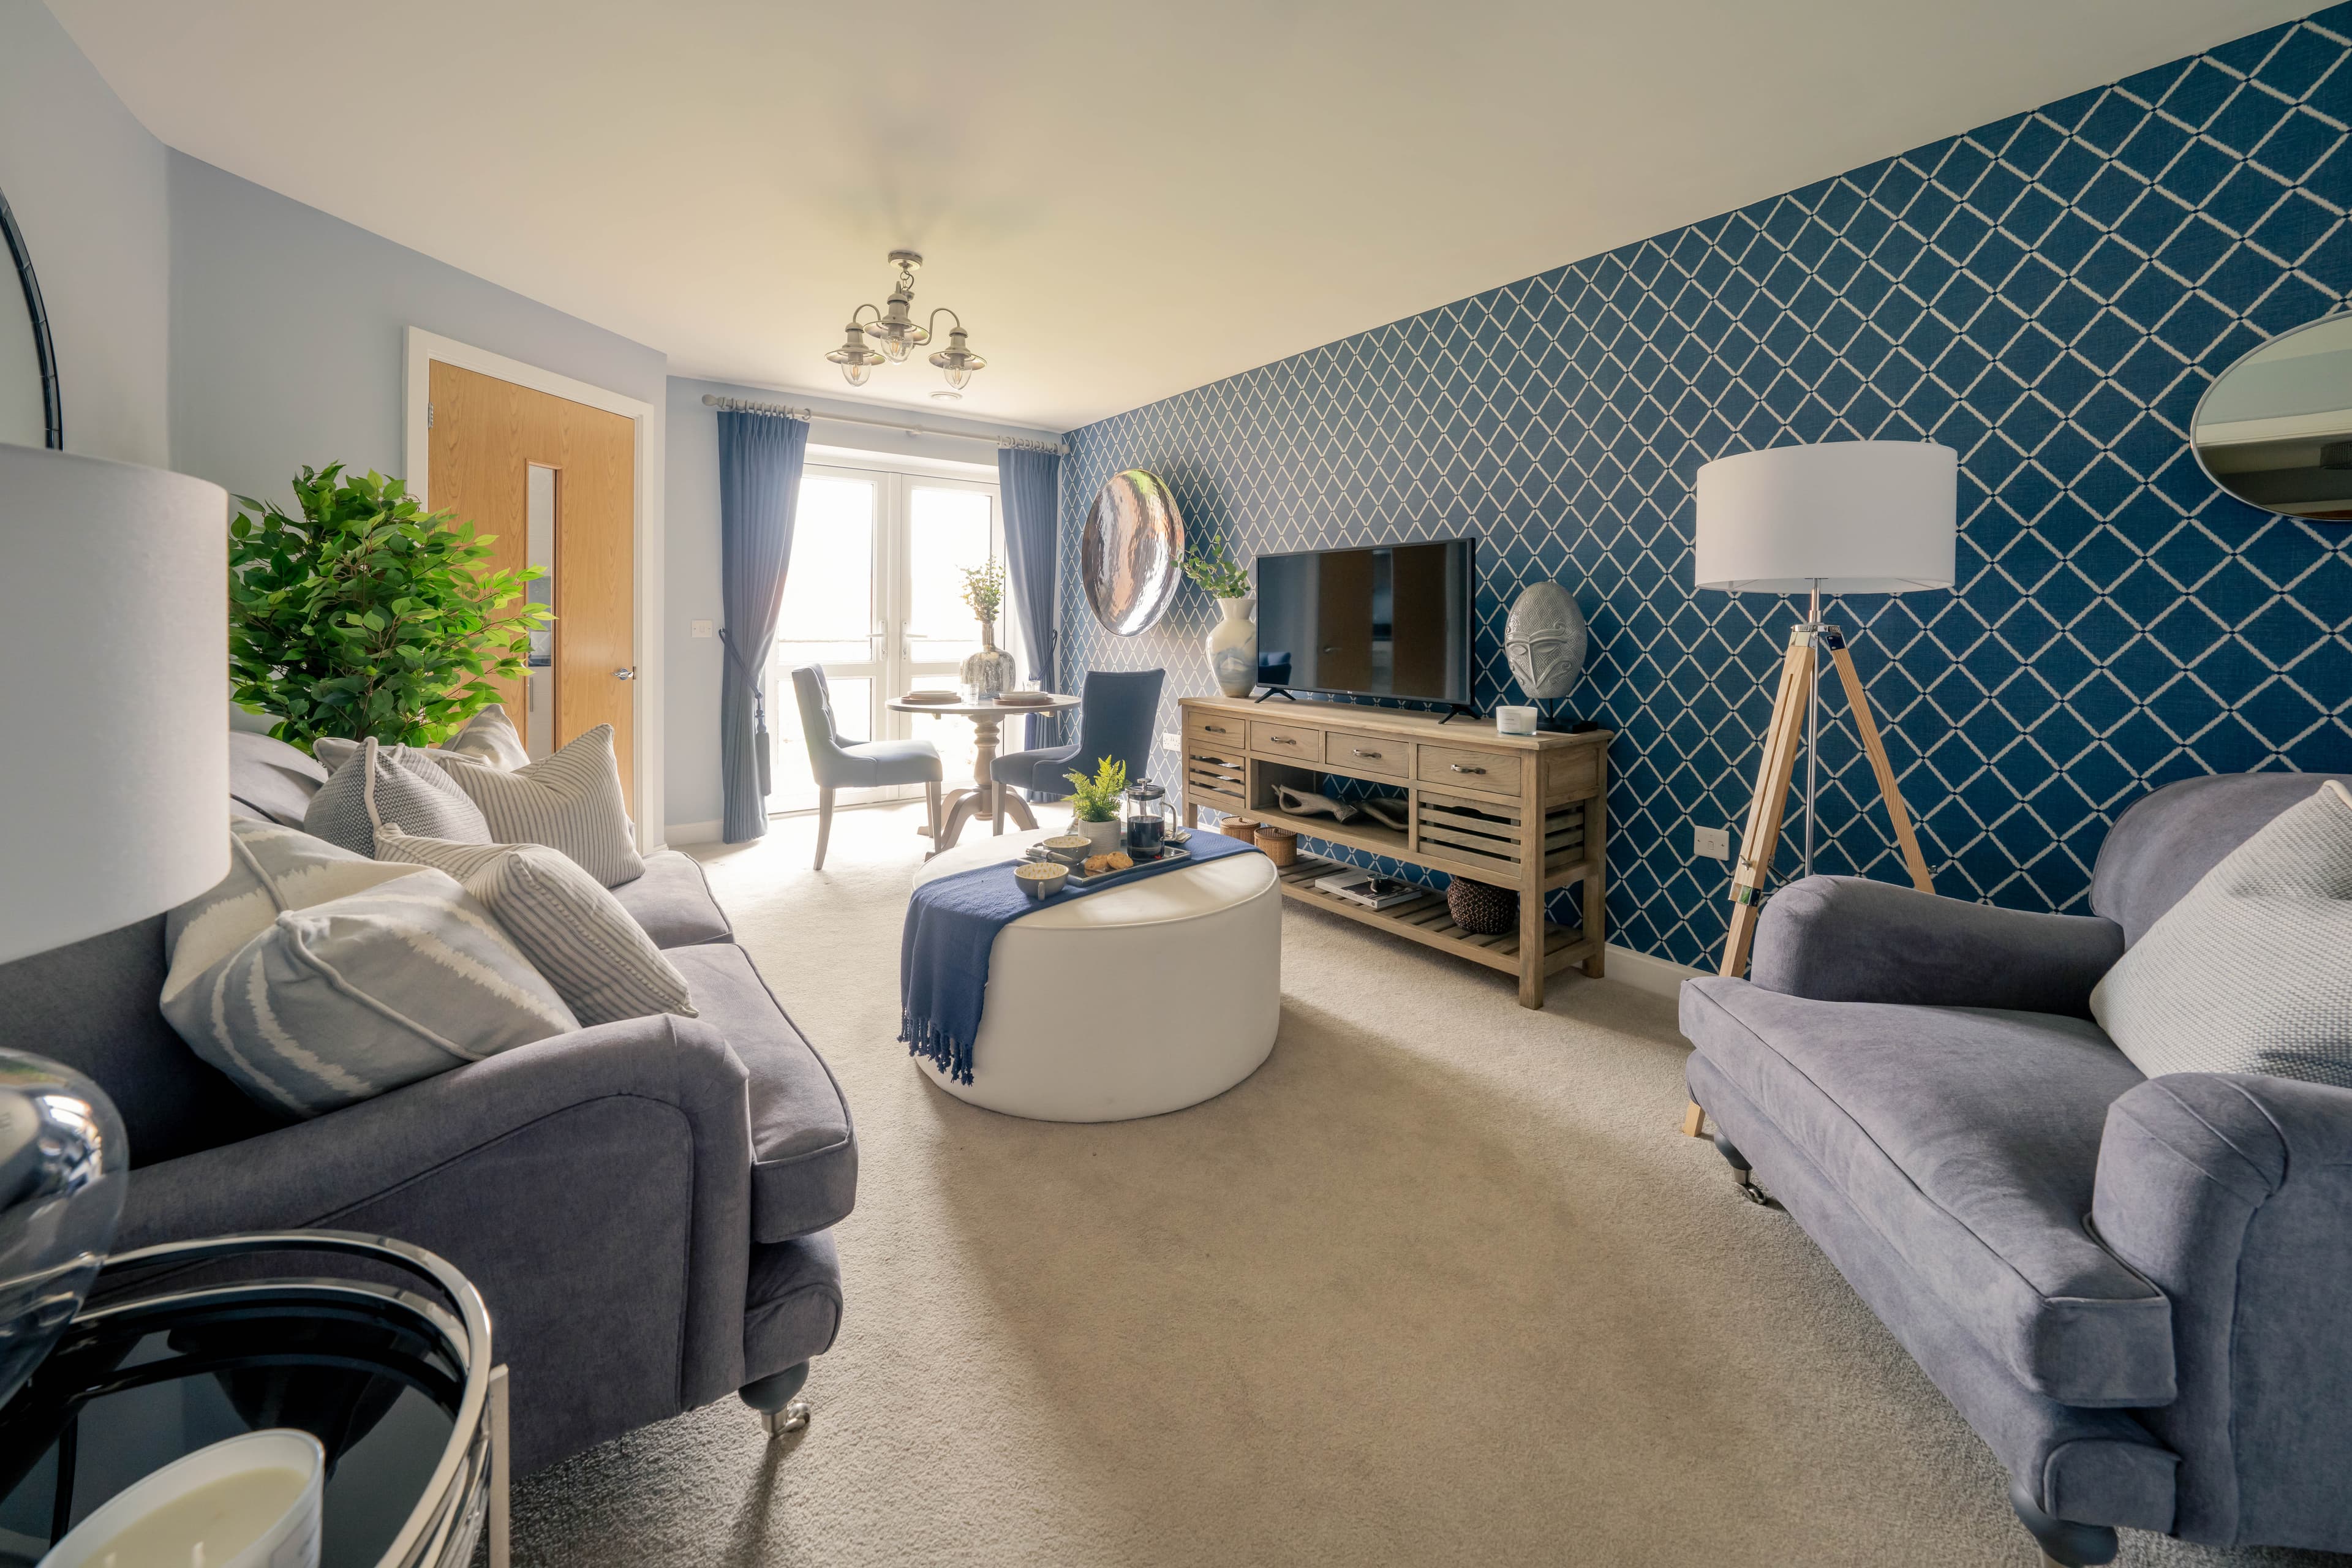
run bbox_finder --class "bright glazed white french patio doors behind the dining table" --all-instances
[767,463,1001,811]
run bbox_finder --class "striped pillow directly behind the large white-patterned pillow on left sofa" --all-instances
[376,827,694,1025]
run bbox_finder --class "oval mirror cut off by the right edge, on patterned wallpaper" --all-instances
[2190,312,2352,522]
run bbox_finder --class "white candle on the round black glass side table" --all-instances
[40,1427,327,1568]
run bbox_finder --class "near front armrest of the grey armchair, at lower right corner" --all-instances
[2091,1072,2352,1545]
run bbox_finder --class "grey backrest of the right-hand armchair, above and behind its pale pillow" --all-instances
[2091,774,2352,943]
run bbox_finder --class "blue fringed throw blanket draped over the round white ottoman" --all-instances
[899,827,1258,1084]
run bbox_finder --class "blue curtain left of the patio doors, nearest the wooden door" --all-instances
[720,412,809,844]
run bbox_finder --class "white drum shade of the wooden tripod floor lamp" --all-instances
[1696,442,1959,592]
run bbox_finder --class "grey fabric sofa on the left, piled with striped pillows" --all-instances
[0,736,859,1469]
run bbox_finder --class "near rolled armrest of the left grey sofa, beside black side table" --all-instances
[118,1016,750,1469]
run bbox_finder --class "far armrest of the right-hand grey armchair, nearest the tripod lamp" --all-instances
[1750,877,2124,1018]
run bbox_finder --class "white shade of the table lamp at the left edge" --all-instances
[0,447,228,962]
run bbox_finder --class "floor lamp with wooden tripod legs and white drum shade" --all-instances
[1694,442,1959,976]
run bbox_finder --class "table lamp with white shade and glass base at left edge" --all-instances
[0,447,228,1401]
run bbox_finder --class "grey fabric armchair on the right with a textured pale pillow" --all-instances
[1682,774,2352,1566]
